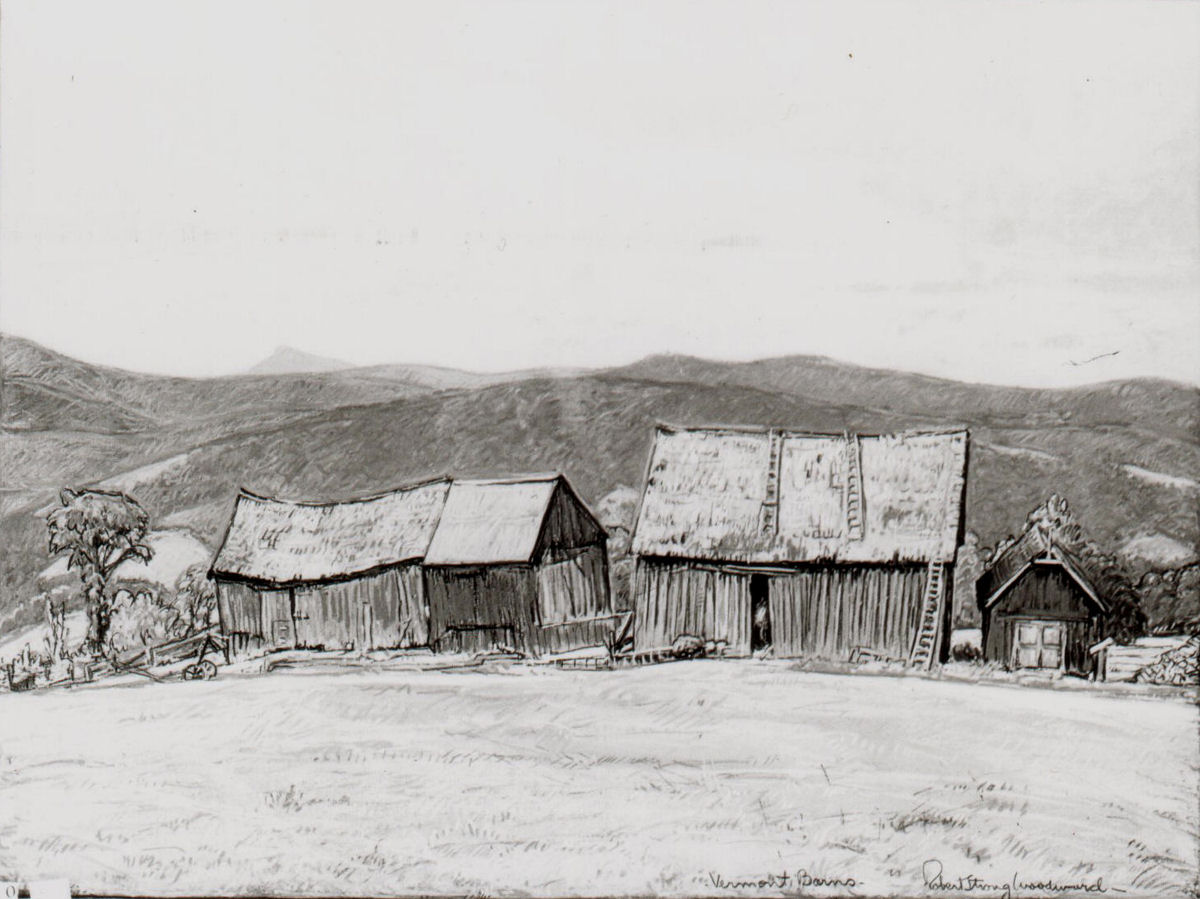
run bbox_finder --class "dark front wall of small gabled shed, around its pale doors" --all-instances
[983,563,1105,673]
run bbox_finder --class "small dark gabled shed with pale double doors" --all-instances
[976,523,1109,675]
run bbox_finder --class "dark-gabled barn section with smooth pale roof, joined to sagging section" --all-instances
[425,474,616,655]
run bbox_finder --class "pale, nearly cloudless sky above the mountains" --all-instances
[0,0,1200,386]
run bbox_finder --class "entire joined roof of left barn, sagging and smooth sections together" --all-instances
[211,474,604,586]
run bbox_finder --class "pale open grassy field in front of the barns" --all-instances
[0,661,1200,897]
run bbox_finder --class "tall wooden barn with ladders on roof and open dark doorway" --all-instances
[632,426,967,665]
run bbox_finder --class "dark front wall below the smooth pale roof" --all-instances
[425,565,538,653]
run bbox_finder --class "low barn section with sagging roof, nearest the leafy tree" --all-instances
[209,478,450,653]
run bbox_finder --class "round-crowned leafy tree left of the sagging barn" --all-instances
[46,489,152,653]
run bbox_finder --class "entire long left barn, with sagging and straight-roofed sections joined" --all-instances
[210,475,616,655]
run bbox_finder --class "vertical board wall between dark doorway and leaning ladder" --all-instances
[767,565,926,660]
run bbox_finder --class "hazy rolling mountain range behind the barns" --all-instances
[0,337,1200,633]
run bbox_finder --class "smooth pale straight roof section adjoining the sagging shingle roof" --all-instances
[425,474,560,565]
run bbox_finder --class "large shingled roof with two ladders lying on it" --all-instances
[632,426,967,563]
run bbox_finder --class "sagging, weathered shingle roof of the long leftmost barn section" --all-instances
[211,478,450,585]
